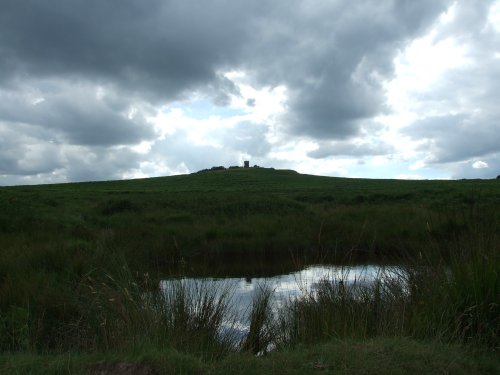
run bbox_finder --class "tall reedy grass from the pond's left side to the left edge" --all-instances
[0,238,236,357]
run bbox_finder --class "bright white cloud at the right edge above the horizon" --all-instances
[394,1,500,177]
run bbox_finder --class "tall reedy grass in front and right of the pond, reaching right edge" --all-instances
[280,229,500,350]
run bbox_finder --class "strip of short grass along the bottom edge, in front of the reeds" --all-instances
[0,338,500,375]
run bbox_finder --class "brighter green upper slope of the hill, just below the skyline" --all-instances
[4,167,500,204]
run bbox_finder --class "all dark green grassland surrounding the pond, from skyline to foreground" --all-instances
[0,168,500,373]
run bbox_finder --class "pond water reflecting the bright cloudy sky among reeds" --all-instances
[161,264,401,344]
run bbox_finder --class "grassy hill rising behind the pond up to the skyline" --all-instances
[0,168,500,266]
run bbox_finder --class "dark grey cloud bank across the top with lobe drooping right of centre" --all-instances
[0,0,446,119]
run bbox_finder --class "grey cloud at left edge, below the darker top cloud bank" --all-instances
[0,81,153,146]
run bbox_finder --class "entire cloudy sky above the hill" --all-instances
[0,0,500,185]
